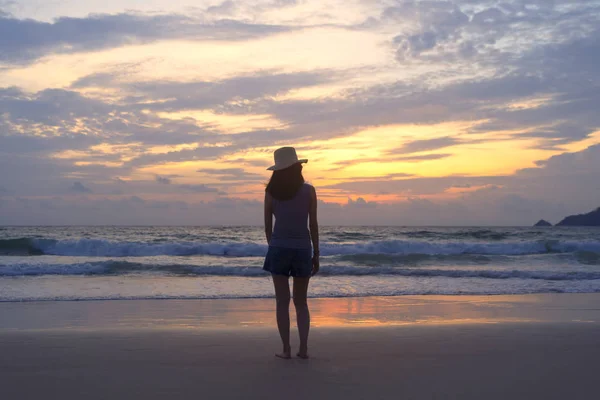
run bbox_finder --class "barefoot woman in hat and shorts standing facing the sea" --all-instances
[263,147,319,359]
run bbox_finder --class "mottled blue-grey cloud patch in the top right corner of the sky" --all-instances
[380,0,600,65]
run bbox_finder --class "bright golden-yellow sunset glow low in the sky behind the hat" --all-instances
[110,119,600,204]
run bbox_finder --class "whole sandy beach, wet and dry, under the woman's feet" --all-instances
[0,294,600,399]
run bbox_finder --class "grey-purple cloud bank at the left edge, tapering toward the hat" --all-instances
[0,75,324,175]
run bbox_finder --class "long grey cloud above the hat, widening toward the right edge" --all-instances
[254,25,600,149]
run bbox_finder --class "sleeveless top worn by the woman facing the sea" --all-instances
[270,183,312,249]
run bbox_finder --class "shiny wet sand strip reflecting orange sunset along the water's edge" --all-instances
[0,294,600,331]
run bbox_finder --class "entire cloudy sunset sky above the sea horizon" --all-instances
[0,0,600,226]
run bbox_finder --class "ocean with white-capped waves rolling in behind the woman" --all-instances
[0,226,600,301]
